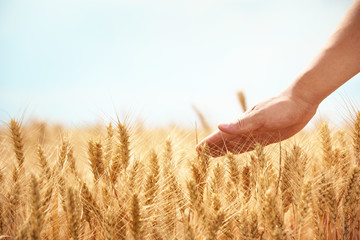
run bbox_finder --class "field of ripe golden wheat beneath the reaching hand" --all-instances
[0,104,360,240]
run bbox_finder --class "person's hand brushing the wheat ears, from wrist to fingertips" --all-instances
[196,92,318,157]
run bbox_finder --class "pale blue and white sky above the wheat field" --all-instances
[0,0,360,126]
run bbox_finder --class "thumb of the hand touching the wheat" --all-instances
[218,114,261,135]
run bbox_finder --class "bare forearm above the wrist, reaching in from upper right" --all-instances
[285,0,360,105]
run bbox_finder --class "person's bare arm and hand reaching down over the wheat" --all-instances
[196,0,360,157]
